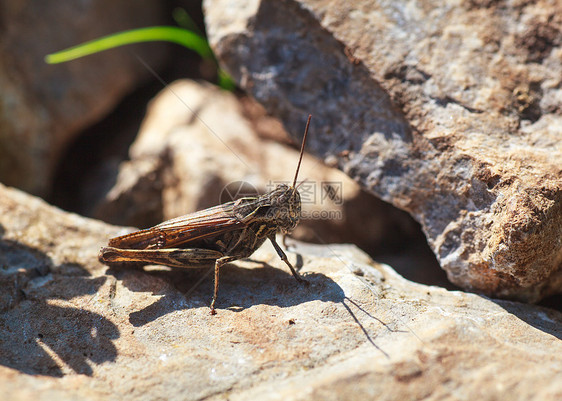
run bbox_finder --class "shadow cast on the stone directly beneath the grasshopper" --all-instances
[108,262,345,327]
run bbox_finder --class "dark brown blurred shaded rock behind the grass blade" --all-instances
[0,0,167,196]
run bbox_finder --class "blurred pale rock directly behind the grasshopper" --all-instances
[91,80,416,255]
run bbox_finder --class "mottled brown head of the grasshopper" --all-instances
[271,184,301,234]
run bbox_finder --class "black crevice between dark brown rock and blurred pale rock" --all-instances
[46,1,208,215]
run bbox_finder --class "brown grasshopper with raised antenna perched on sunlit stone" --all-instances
[99,115,312,314]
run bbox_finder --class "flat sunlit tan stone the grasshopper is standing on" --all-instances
[0,185,562,401]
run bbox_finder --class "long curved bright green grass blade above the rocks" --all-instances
[45,26,213,64]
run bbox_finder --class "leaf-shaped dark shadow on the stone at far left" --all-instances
[0,228,119,377]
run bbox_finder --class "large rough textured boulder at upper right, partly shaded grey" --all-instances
[205,0,562,301]
